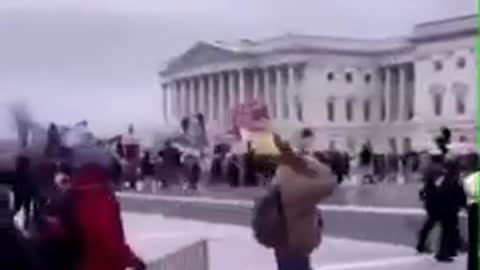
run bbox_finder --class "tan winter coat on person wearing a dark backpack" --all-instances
[274,157,336,255]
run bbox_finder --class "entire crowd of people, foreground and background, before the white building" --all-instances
[0,105,479,270]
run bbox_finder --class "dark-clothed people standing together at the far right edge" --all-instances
[416,128,480,269]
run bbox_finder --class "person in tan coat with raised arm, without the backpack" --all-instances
[274,129,336,270]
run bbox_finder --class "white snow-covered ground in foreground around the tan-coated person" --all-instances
[124,213,465,270]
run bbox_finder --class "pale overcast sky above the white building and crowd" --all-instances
[0,0,476,138]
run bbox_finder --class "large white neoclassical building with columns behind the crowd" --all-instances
[160,15,478,153]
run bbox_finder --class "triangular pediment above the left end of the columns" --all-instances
[164,42,241,73]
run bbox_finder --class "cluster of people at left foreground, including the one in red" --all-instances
[0,123,146,270]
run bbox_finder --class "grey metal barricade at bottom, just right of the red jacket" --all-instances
[148,240,209,270]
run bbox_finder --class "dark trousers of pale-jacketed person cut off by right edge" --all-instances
[467,203,479,270]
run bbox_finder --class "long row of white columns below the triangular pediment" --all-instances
[163,65,303,124]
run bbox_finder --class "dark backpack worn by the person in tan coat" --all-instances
[252,186,288,248]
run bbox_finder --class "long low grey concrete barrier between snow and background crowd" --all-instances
[119,194,467,246]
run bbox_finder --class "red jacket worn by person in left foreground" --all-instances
[71,163,145,270]
